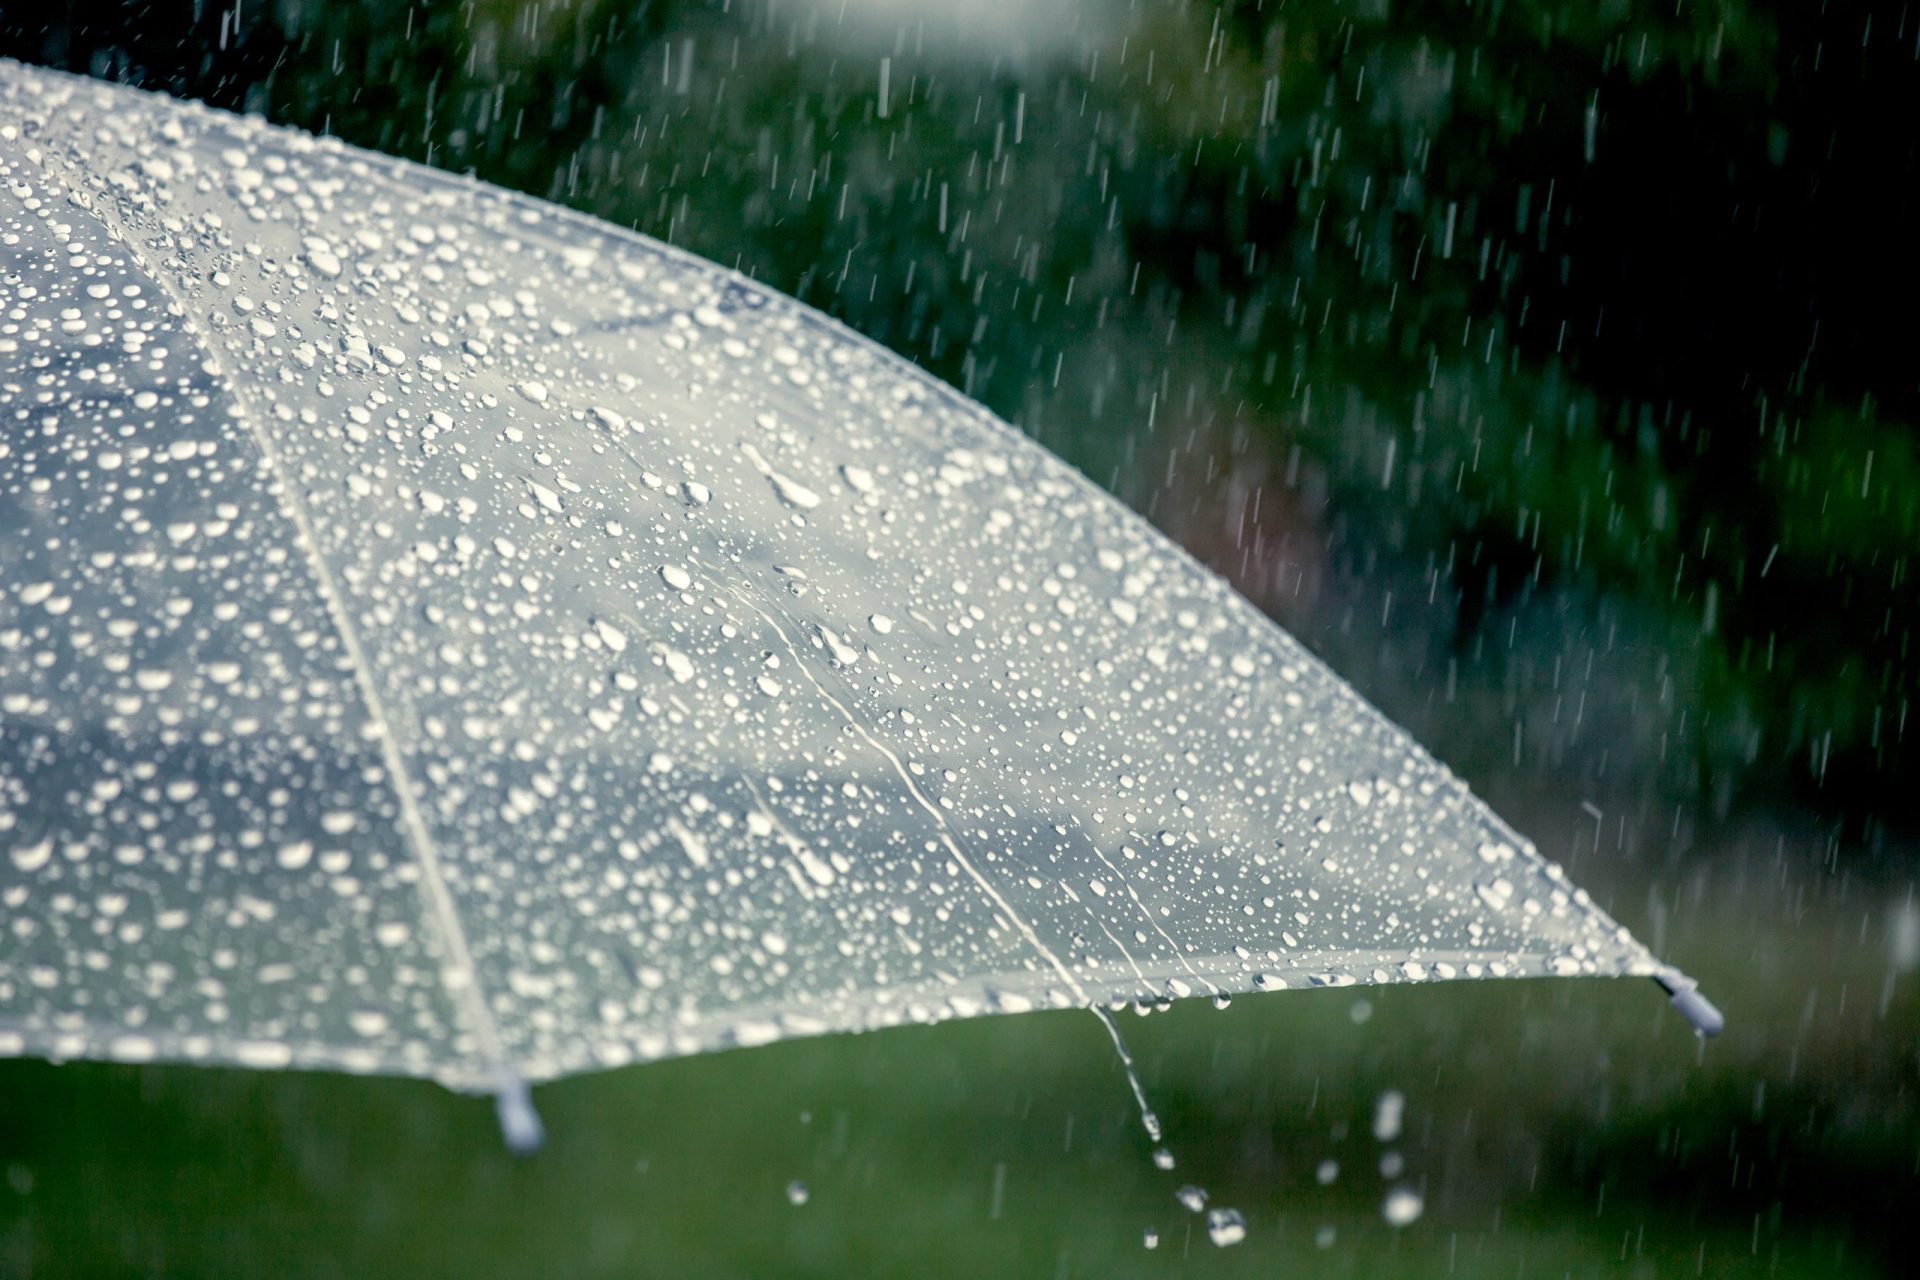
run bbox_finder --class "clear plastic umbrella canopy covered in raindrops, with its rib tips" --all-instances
[0,65,1718,1142]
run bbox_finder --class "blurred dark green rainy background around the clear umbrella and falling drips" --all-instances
[0,0,1920,1276]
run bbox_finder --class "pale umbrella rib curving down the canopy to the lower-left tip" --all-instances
[67,169,543,1153]
